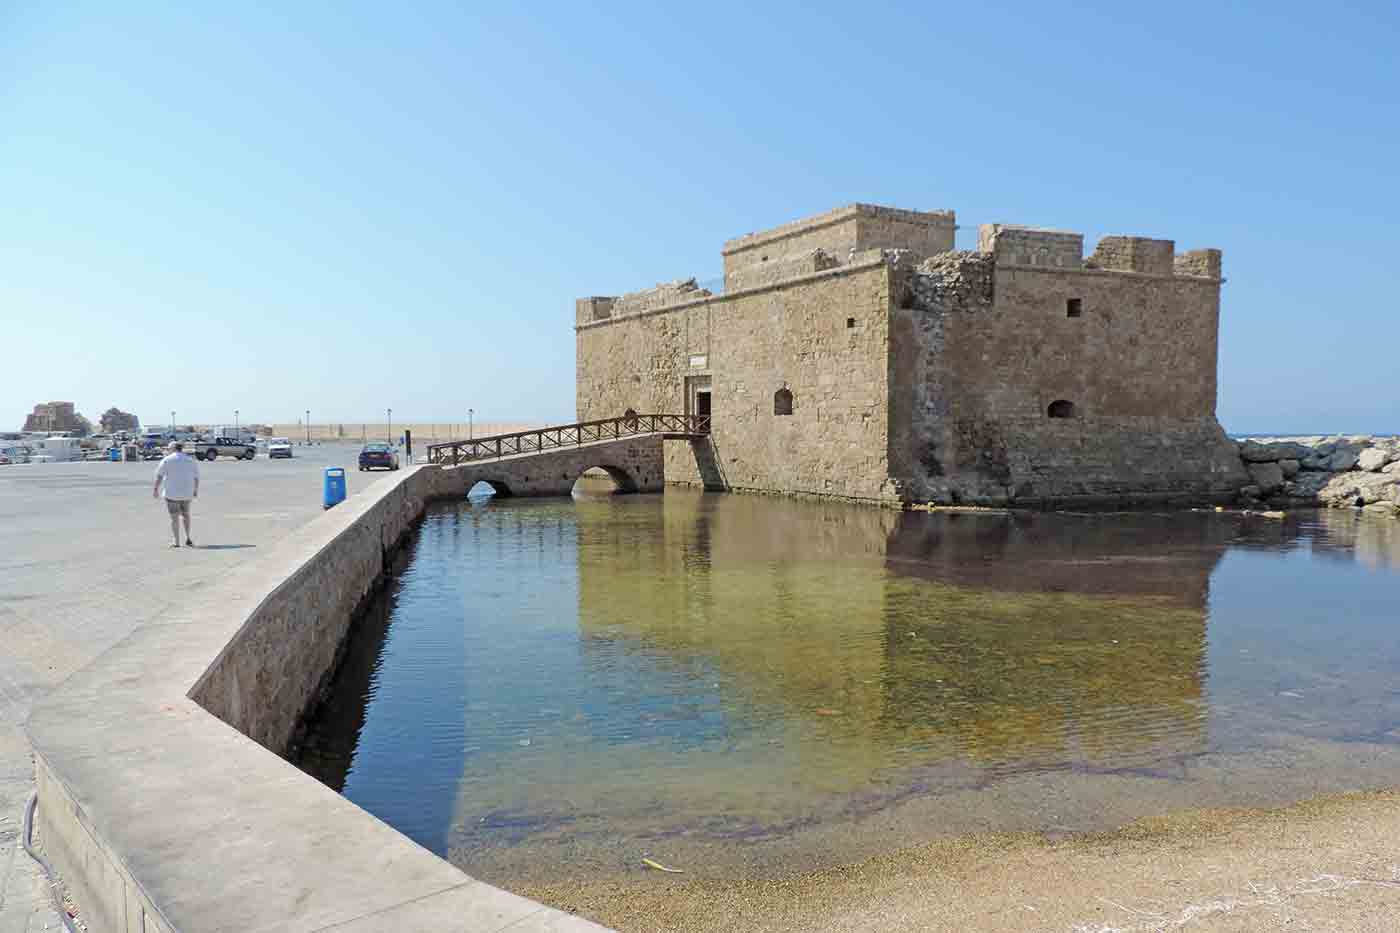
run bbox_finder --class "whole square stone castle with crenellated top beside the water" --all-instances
[575,205,1247,506]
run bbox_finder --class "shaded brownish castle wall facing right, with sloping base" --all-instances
[890,228,1242,504]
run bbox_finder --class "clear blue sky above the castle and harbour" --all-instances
[0,0,1400,431]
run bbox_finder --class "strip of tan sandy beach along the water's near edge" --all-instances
[522,792,1400,933]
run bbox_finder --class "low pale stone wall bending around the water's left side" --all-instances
[27,467,602,933]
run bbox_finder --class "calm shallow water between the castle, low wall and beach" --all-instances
[298,490,1400,885]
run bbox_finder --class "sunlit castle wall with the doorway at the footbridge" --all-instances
[577,252,893,500]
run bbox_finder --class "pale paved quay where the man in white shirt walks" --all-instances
[0,445,377,933]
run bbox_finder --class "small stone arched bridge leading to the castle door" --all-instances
[444,434,666,496]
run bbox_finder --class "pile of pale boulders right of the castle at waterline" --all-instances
[1239,436,1400,517]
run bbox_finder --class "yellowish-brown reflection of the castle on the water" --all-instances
[578,493,1231,780]
